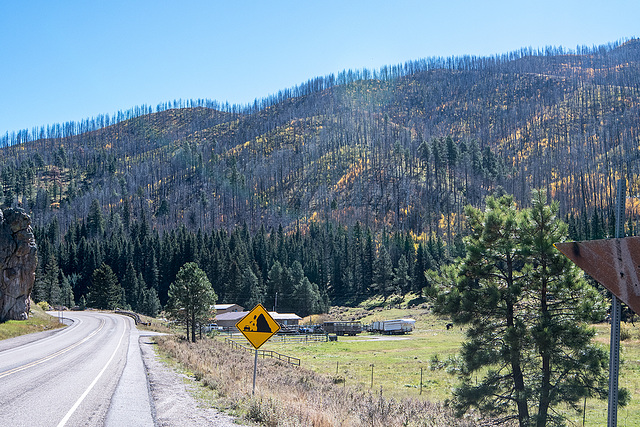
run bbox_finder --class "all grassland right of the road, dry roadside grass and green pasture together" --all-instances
[158,294,640,427]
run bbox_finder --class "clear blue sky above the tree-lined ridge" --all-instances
[0,0,640,135]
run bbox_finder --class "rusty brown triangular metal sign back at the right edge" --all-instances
[555,236,640,313]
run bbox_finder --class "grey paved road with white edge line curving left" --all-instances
[0,312,154,427]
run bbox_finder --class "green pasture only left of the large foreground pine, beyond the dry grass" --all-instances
[261,310,464,401]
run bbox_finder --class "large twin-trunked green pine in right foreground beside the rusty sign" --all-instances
[436,192,626,427]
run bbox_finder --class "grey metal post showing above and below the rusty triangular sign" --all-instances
[607,179,626,427]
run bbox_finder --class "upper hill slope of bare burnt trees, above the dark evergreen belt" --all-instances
[0,40,640,238]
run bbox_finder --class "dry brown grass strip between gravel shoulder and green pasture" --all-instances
[157,336,475,427]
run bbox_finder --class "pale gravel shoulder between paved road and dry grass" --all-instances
[139,336,250,427]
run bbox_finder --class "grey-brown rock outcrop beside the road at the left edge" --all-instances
[0,208,38,322]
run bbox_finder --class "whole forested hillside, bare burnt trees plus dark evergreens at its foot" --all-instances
[0,40,640,312]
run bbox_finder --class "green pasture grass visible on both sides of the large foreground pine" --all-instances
[240,306,640,426]
